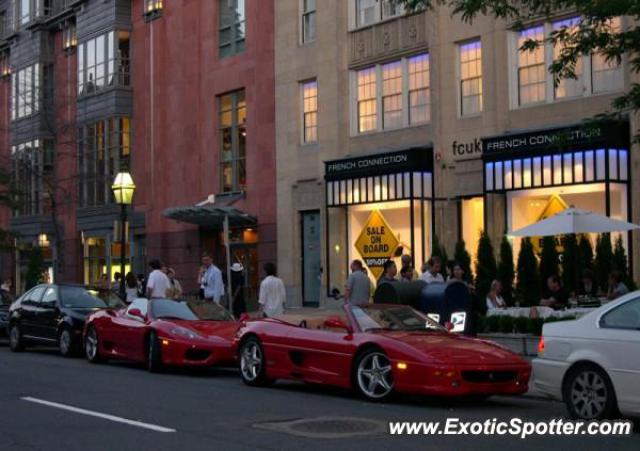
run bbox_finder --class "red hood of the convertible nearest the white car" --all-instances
[377,331,525,365]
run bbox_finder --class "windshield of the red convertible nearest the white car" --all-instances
[351,304,446,332]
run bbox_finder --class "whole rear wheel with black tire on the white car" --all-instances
[562,363,618,420]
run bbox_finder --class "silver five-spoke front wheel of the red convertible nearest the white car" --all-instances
[355,349,394,401]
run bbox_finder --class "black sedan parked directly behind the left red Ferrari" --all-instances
[7,284,124,357]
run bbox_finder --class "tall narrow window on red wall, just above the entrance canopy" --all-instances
[218,89,247,193]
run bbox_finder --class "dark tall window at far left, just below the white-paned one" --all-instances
[11,139,55,216]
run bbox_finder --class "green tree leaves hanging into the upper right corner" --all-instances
[396,0,640,140]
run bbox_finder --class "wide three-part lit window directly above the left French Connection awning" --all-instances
[354,53,431,133]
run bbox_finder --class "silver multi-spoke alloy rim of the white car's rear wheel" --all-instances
[570,371,609,419]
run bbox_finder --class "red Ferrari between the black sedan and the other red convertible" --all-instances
[84,299,239,371]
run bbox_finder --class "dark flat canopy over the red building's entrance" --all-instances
[162,196,258,229]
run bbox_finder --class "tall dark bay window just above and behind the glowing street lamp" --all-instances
[78,117,131,207]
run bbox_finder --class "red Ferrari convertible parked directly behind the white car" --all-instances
[238,304,531,400]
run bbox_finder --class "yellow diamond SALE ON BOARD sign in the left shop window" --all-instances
[355,210,400,279]
